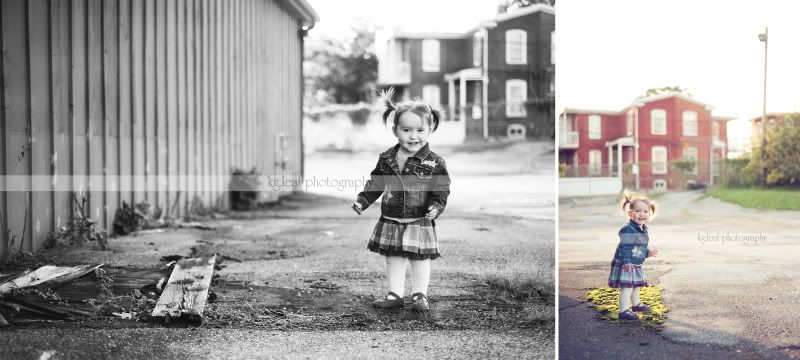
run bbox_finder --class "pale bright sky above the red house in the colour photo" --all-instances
[556,0,800,149]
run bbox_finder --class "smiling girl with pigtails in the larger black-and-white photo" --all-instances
[352,89,450,311]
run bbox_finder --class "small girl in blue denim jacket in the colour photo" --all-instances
[608,189,658,320]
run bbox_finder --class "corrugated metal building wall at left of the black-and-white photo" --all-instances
[0,0,302,254]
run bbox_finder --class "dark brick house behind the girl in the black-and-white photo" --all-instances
[378,4,555,139]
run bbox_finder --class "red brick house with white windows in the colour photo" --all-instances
[558,93,733,190]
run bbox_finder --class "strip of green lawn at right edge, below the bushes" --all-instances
[710,188,800,210]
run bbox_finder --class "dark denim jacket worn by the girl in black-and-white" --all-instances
[356,144,450,219]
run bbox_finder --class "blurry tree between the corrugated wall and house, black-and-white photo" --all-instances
[303,23,378,104]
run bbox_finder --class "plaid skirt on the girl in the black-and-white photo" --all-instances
[367,216,441,260]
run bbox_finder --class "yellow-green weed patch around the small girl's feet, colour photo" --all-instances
[586,286,669,325]
